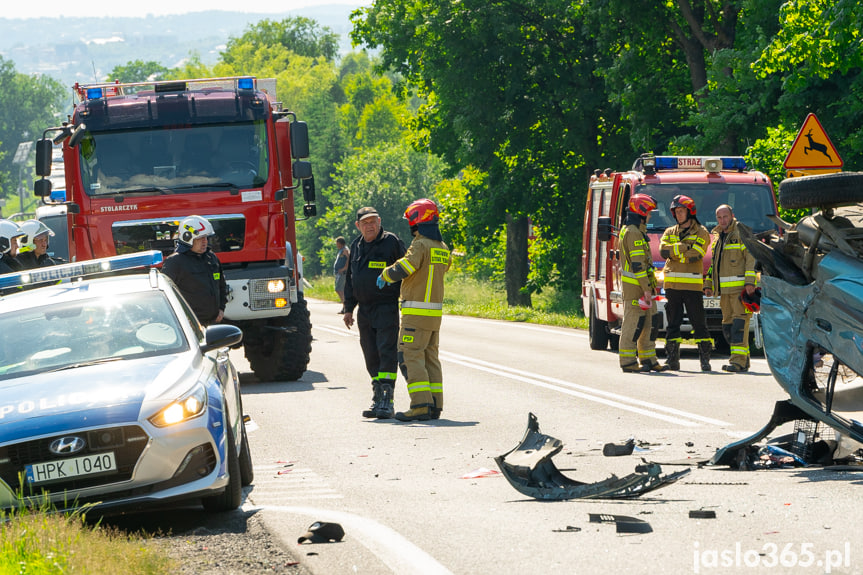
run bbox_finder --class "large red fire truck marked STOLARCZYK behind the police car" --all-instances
[34,77,316,381]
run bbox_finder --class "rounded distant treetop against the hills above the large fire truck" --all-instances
[221,16,339,64]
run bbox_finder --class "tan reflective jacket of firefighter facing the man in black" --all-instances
[383,233,450,318]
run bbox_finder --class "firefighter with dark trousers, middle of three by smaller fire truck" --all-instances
[659,196,713,371]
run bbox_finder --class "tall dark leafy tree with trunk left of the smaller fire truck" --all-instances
[352,0,618,305]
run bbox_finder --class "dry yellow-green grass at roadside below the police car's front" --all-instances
[0,505,177,575]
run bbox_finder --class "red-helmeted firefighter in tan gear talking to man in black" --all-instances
[377,198,450,421]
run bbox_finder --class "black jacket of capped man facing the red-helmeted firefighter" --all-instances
[345,228,405,313]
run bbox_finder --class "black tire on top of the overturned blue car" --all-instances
[779,172,863,210]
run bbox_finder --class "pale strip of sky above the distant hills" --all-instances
[0,0,364,18]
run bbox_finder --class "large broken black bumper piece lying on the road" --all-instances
[494,413,690,501]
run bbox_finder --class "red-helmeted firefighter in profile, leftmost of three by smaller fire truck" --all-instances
[618,194,668,372]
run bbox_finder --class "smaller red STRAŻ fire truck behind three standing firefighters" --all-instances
[581,154,777,349]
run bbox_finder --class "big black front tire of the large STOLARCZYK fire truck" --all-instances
[244,296,312,381]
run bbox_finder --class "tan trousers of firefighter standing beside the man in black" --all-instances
[399,316,443,409]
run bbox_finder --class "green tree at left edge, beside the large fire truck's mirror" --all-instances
[0,56,66,211]
